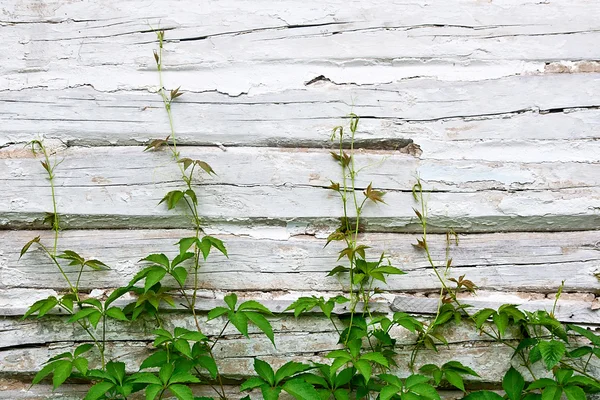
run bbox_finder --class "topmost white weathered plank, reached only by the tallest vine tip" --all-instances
[0,1,598,93]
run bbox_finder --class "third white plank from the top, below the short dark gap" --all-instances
[0,147,600,232]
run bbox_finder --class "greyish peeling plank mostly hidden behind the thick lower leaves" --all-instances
[0,314,600,382]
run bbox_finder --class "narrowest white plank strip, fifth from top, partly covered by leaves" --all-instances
[0,288,600,324]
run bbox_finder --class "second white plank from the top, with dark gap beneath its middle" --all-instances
[0,74,600,150]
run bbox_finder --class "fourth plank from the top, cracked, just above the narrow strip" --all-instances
[0,230,600,293]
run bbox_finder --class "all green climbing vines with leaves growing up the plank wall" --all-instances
[19,31,600,400]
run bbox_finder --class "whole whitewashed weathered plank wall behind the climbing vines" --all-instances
[0,0,600,399]
